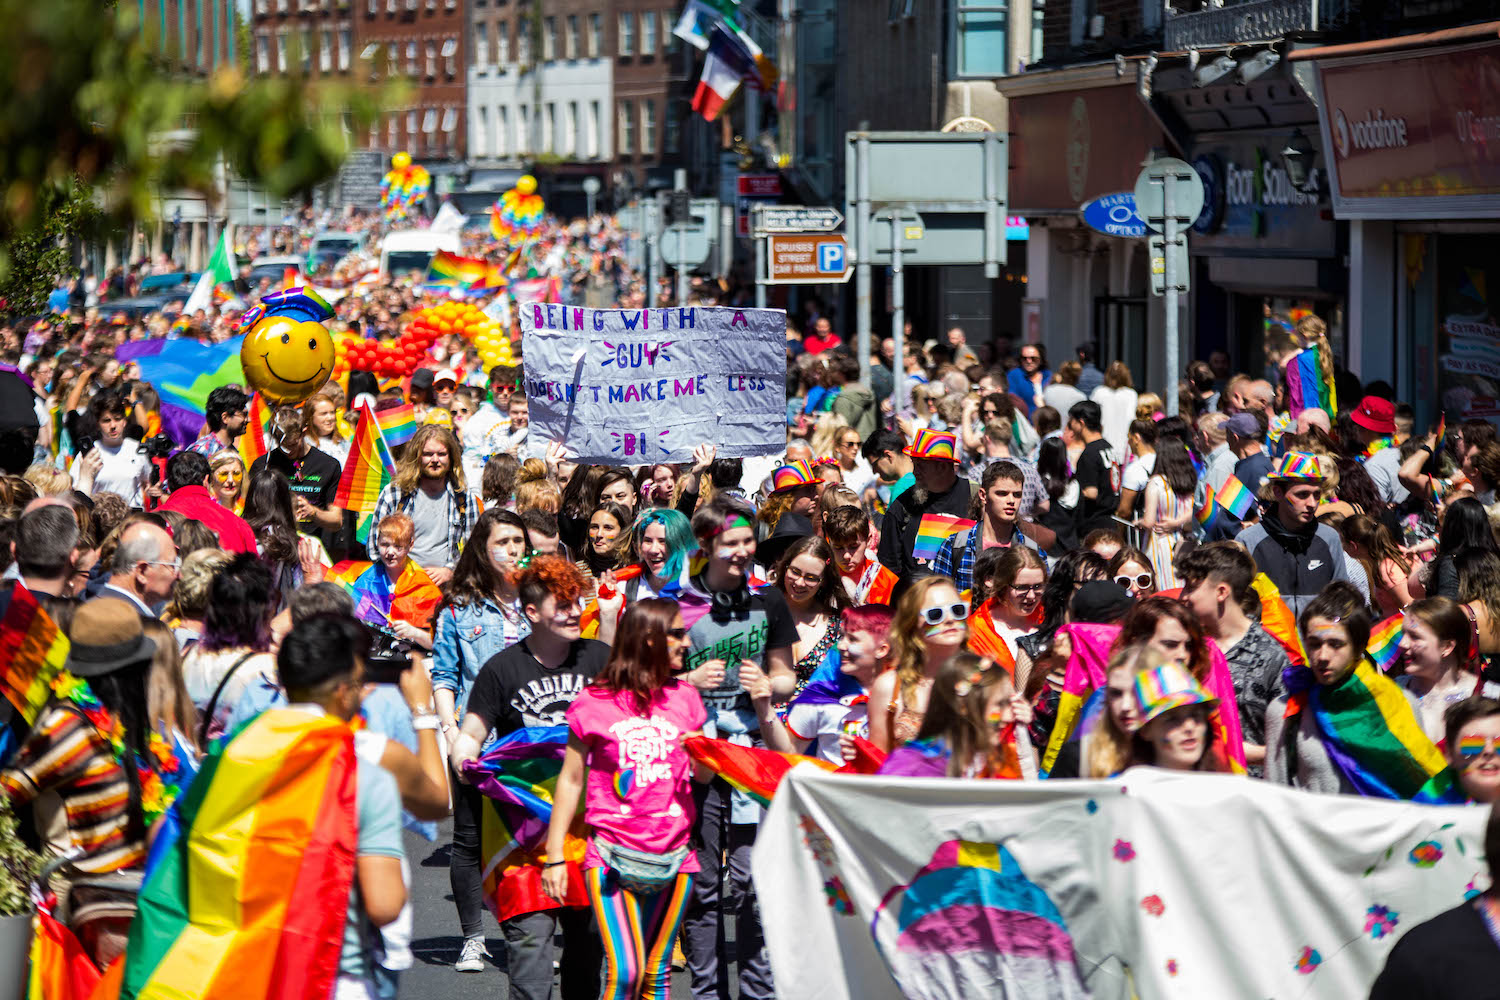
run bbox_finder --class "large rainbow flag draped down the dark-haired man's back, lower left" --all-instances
[120,708,359,1000]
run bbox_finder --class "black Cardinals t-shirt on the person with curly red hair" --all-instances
[468,639,609,736]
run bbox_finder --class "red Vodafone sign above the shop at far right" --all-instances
[1317,42,1500,219]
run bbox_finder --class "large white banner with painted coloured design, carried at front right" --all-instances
[753,766,1490,1000]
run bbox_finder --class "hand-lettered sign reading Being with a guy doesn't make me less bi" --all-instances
[518,303,786,465]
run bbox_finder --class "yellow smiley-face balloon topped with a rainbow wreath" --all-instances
[239,288,333,405]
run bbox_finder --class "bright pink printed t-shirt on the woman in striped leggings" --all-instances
[567,681,708,871]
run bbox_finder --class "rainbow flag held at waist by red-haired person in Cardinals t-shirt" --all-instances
[464,726,588,921]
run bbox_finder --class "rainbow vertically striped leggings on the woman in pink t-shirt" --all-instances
[585,868,693,1000]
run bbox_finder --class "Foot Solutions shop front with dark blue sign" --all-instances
[1188,129,1349,380]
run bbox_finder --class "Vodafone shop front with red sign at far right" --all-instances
[1292,24,1500,426]
